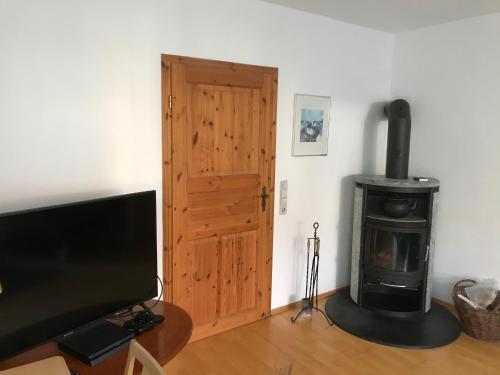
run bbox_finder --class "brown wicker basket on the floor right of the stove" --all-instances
[453,279,500,341]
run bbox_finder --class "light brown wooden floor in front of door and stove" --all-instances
[166,302,500,375]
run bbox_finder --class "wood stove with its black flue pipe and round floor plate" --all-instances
[325,99,461,348]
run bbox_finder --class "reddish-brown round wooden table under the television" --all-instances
[0,301,193,375]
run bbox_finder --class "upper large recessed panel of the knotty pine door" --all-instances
[188,85,260,177]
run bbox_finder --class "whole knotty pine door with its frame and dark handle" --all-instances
[162,55,278,339]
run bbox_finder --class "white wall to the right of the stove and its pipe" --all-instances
[392,14,500,301]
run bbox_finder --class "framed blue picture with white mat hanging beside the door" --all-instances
[292,94,330,156]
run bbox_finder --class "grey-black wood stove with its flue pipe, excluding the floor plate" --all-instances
[351,99,439,318]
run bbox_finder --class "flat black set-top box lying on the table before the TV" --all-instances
[58,320,135,366]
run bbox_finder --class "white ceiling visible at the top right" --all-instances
[264,0,500,33]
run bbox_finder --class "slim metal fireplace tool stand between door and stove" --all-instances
[291,222,333,325]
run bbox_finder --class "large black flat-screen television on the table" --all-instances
[0,191,157,359]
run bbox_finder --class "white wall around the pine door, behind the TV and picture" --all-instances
[0,0,393,307]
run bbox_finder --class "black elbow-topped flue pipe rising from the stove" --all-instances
[384,99,411,179]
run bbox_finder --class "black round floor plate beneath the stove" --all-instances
[325,290,461,349]
